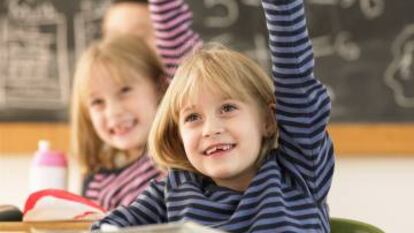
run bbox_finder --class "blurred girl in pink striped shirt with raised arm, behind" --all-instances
[71,2,200,210]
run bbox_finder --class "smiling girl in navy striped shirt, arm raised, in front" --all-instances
[93,0,334,233]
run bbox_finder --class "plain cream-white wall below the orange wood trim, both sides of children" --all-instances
[0,155,414,233]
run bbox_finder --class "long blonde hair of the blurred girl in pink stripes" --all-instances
[71,35,166,175]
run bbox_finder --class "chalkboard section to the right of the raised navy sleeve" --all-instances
[306,0,414,122]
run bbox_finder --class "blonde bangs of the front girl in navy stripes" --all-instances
[170,49,251,122]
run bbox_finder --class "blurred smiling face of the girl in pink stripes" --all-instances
[87,69,159,155]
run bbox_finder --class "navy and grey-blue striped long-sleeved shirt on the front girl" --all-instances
[93,0,334,233]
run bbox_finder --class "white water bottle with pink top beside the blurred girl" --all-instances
[29,140,67,192]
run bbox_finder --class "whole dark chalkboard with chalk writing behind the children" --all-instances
[0,0,414,122]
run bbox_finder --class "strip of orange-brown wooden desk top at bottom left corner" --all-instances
[0,221,92,233]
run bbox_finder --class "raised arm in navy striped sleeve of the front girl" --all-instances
[262,0,334,202]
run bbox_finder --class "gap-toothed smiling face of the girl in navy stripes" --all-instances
[179,85,265,191]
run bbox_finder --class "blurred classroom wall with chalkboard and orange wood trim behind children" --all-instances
[0,0,414,233]
